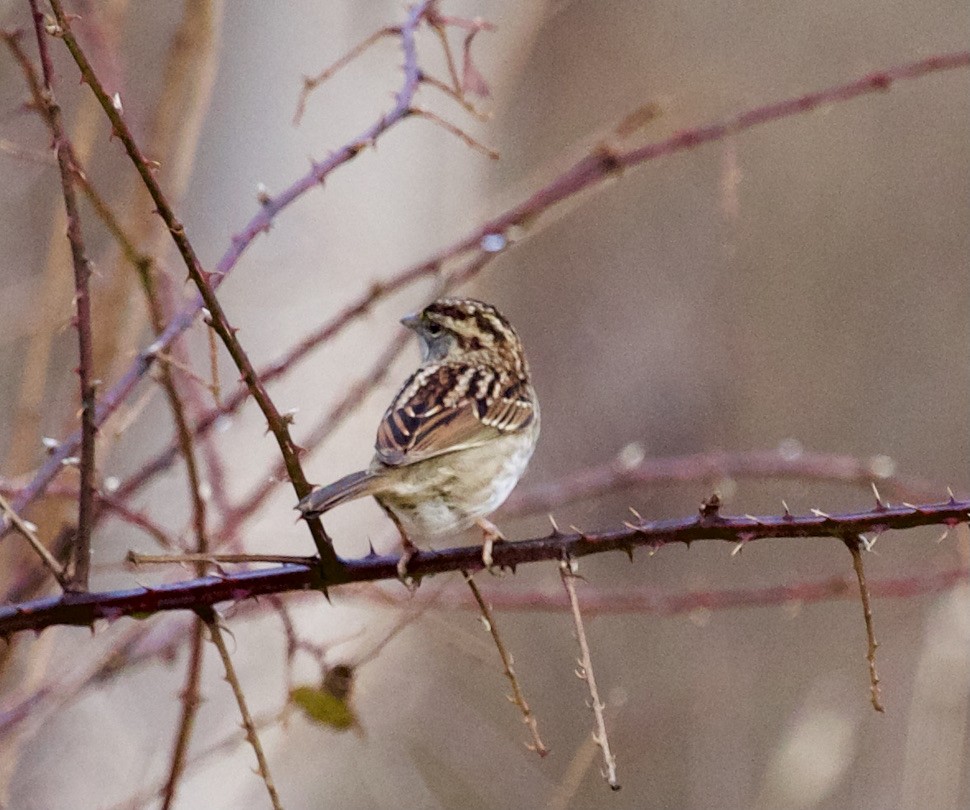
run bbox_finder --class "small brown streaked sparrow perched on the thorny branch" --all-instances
[297,298,539,578]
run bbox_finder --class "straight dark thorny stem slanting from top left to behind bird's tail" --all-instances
[47,0,340,571]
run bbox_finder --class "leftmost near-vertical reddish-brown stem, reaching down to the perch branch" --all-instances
[30,0,97,591]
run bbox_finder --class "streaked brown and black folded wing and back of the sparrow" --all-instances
[376,364,535,467]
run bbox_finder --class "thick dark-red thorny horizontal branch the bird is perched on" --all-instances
[0,492,970,635]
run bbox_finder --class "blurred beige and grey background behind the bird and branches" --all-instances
[0,0,970,810]
